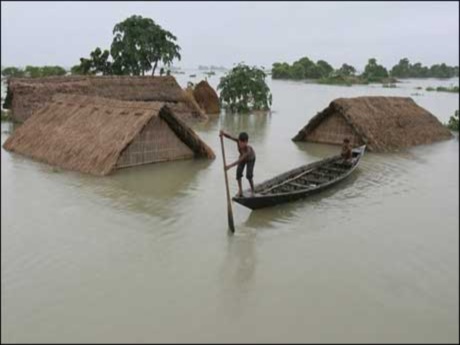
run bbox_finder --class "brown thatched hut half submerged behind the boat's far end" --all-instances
[292,97,452,151]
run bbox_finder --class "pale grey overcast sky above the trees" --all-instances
[1,1,459,69]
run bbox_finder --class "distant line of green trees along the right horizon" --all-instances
[272,57,458,84]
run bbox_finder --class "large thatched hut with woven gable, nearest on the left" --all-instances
[3,94,215,175]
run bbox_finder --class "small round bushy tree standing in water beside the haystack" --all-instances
[217,63,272,113]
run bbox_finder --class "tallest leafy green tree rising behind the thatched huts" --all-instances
[110,16,181,75]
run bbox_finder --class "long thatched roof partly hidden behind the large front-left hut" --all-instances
[6,76,207,122]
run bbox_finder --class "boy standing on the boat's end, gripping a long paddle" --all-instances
[219,130,256,197]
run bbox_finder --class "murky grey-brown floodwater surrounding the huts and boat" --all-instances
[1,75,459,342]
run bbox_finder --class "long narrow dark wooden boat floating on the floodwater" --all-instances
[233,145,366,210]
